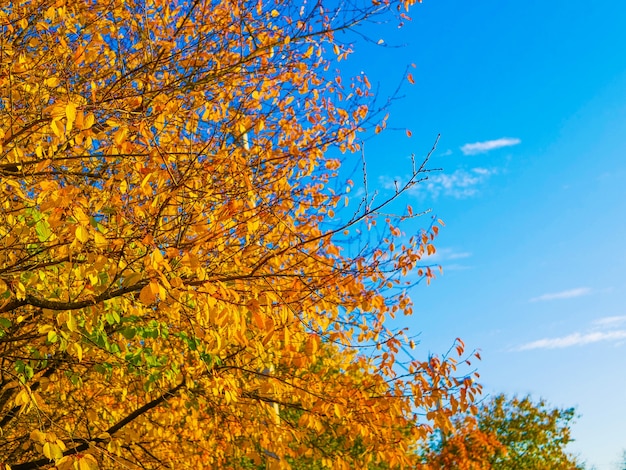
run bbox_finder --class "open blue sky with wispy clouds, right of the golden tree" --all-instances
[336,0,626,470]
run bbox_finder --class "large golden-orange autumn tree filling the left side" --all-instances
[0,0,478,470]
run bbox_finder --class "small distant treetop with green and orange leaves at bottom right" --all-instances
[425,394,584,470]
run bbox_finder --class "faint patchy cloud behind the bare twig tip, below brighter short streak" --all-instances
[380,168,497,199]
